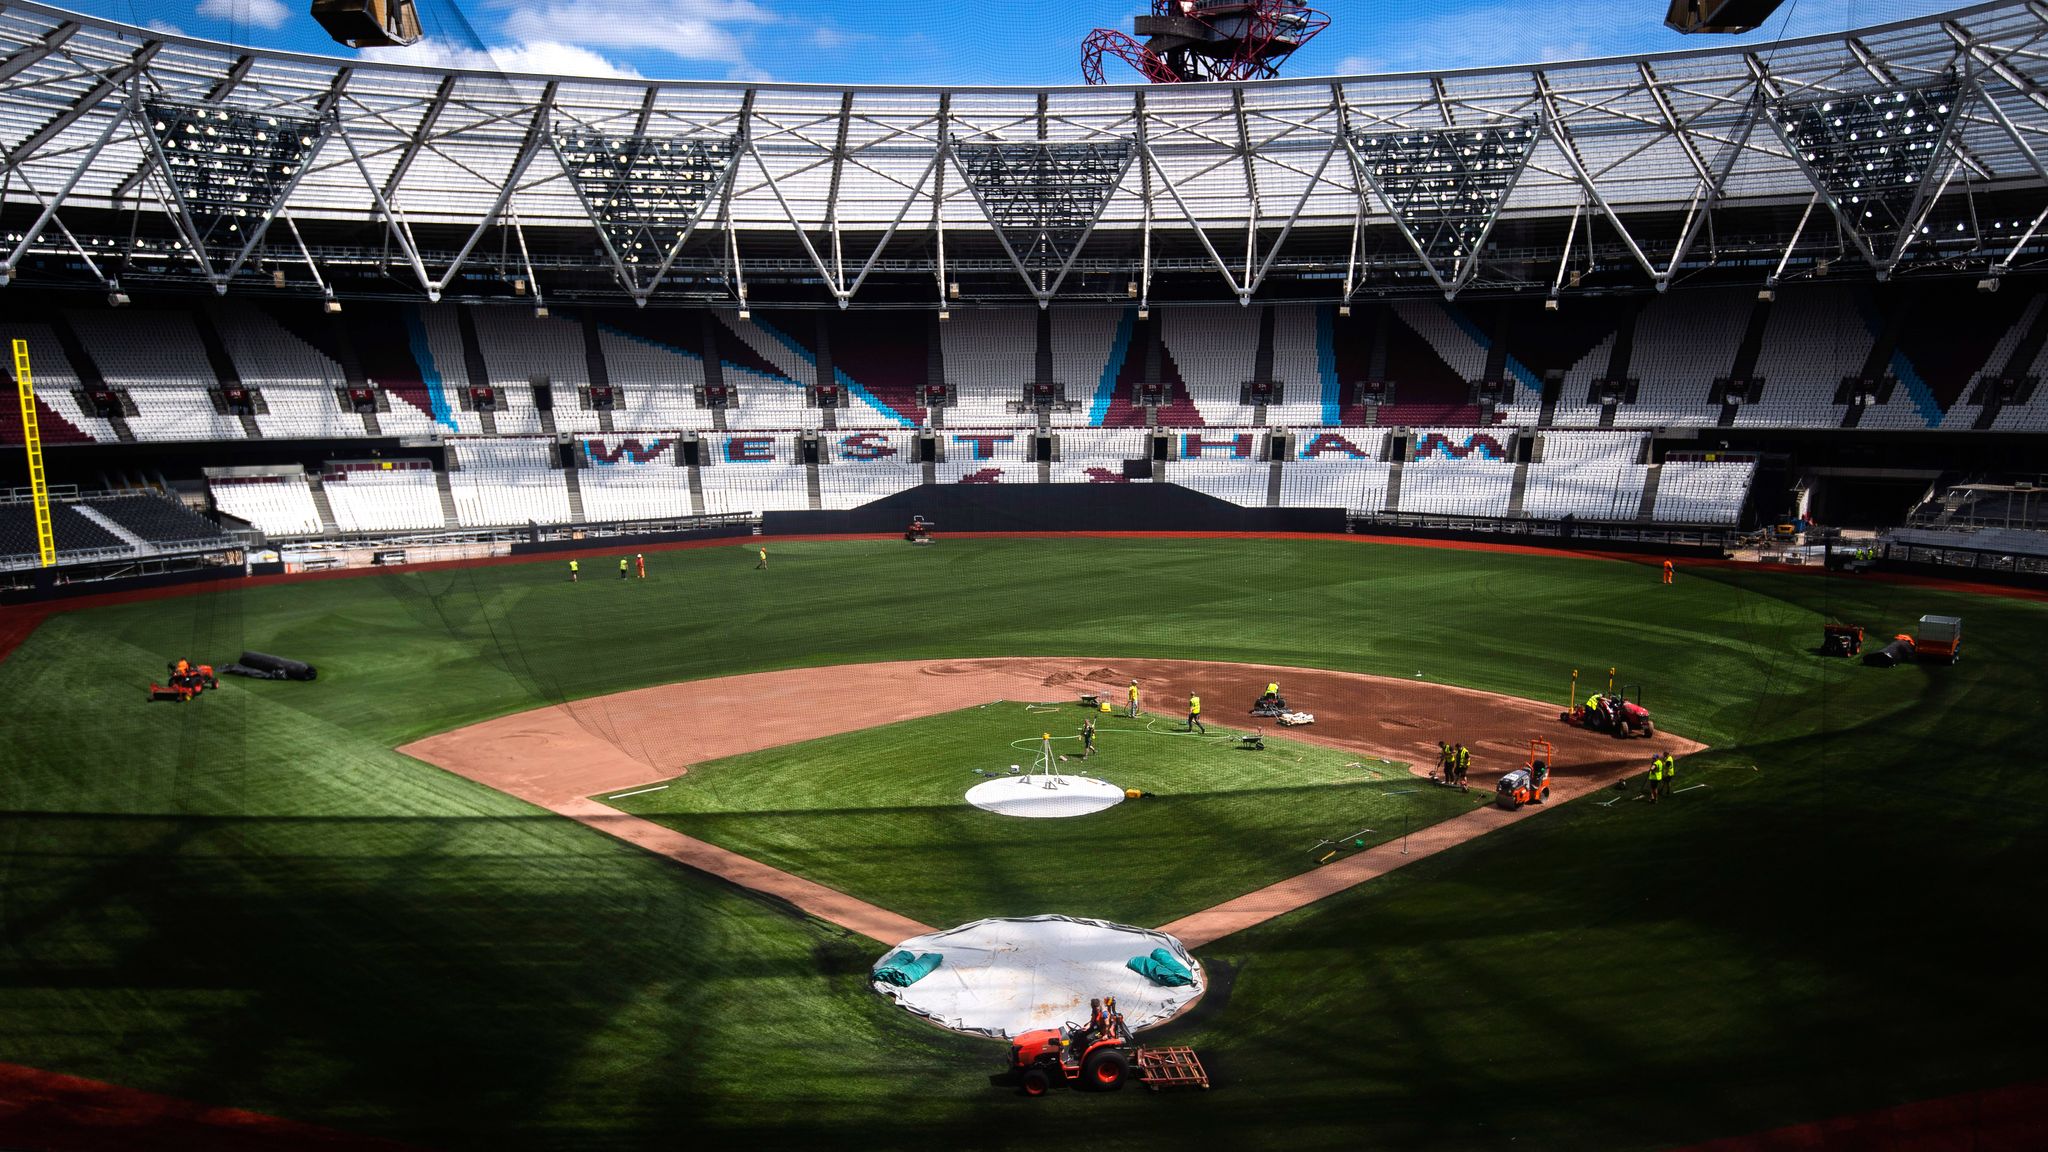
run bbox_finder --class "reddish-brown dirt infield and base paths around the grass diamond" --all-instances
[399,658,1700,947]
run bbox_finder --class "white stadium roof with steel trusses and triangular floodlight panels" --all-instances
[12,0,2048,303]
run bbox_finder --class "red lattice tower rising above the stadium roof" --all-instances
[1081,0,1329,84]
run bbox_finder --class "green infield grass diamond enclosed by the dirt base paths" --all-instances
[600,701,1493,929]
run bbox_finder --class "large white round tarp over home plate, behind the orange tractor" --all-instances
[874,916,1208,1039]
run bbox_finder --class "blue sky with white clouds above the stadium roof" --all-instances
[75,0,1960,84]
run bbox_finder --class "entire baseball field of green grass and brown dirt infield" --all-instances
[0,537,2048,1148]
